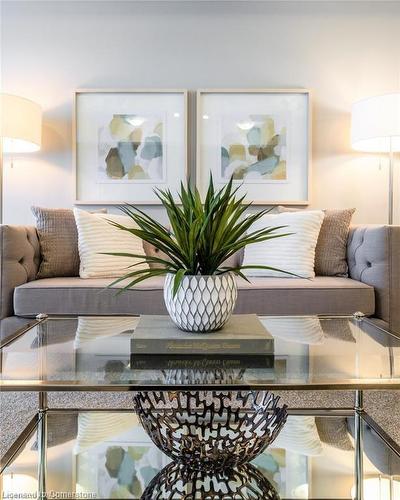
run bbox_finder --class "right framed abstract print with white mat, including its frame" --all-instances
[197,89,311,205]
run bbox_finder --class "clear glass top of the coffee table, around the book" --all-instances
[0,316,400,391]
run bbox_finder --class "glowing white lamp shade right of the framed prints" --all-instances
[351,93,400,153]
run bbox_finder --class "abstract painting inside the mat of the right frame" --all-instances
[220,114,287,182]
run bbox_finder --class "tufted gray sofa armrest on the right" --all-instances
[347,225,400,333]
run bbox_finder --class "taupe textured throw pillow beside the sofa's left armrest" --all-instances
[31,207,107,279]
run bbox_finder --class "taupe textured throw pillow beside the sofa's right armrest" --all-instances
[278,207,356,276]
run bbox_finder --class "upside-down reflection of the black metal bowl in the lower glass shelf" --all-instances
[141,462,280,500]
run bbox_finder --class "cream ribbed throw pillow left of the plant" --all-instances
[74,208,148,278]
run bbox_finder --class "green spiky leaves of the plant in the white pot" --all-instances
[107,177,292,295]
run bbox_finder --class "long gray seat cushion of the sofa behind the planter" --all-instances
[14,276,375,316]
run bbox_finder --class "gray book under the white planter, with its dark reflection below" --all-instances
[131,314,274,370]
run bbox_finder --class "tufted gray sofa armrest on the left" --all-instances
[0,225,40,319]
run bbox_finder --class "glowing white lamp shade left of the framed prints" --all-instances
[0,94,42,153]
